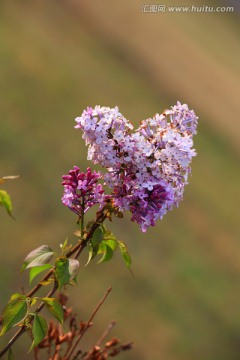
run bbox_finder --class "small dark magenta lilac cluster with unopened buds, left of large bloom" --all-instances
[62,166,104,217]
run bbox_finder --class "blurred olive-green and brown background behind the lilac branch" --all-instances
[0,0,240,360]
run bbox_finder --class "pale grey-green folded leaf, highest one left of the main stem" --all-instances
[21,245,53,271]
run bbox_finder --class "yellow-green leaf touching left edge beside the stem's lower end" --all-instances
[0,294,29,336]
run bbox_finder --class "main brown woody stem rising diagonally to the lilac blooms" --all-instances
[0,207,107,358]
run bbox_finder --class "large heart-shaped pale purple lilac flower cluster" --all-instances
[63,102,197,232]
